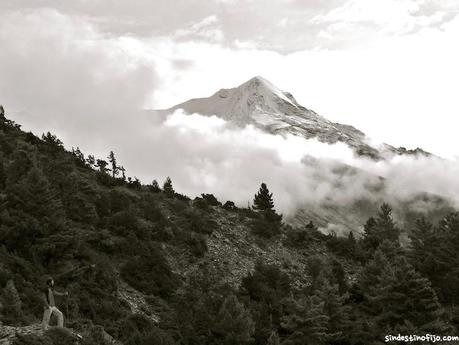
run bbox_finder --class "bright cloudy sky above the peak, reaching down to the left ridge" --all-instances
[0,0,459,157]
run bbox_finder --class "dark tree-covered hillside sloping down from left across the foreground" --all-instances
[0,114,459,345]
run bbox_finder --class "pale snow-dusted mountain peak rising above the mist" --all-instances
[160,76,379,157]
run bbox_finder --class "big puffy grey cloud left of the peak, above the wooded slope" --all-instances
[0,10,155,150]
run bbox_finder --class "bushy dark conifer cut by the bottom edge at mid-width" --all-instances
[214,294,254,345]
